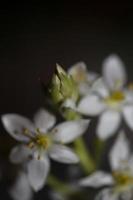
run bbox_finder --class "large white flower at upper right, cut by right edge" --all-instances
[77,55,133,139]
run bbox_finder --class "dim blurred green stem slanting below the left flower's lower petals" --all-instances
[48,175,75,195]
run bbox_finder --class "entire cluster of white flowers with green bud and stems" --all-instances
[1,55,133,200]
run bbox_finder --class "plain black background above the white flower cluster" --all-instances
[0,1,133,199]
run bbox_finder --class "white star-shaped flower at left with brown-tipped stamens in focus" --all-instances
[2,109,89,191]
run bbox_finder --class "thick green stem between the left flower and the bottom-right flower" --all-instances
[74,137,96,174]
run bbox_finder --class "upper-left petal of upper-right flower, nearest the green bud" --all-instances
[92,78,109,97]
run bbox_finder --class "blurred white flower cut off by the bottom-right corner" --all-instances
[79,131,133,200]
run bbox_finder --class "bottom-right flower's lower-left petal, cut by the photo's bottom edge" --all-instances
[95,188,119,200]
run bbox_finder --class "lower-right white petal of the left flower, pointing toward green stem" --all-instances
[49,144,79,164]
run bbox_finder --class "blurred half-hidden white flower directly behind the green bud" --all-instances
[68,62,98,95]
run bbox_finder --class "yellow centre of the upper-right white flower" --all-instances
[105,91,125,105]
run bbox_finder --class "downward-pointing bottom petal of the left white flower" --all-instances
[28,158,50,191]
